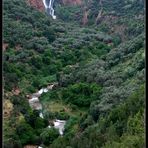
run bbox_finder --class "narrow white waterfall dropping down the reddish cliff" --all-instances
[43,0,56,19]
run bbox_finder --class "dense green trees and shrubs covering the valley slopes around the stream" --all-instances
[3,0,145,148]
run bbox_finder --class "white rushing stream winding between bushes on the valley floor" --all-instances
[29,84,66,136]
